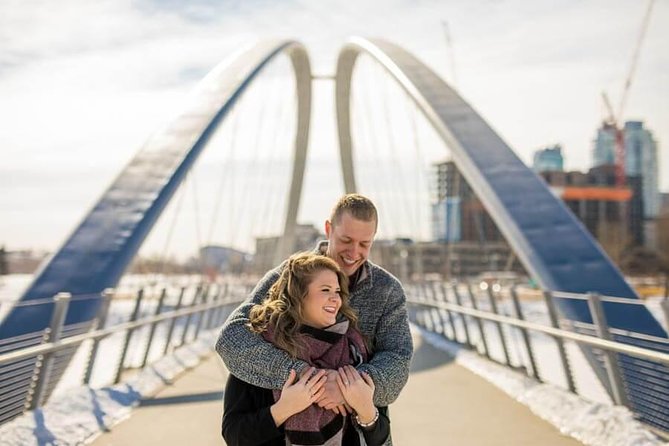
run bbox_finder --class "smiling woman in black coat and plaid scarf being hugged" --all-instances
[222,253,390,446]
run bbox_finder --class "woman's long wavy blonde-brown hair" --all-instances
[248,252,358,358]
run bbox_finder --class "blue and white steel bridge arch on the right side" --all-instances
[335,37,669,430]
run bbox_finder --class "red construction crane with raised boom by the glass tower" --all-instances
[602,0,655,187]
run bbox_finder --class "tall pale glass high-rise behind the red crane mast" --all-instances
[592,121,660,219]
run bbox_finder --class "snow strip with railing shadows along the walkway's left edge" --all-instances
[0,330,218,446]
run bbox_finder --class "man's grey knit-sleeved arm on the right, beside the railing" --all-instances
[358,280,413,406]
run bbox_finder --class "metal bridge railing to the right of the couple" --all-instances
[406,282,669,438]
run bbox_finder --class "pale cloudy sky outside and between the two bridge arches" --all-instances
[0,0,669,258]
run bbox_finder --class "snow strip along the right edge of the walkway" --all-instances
[412,325,669,446]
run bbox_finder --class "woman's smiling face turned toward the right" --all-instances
[302,269,341,328]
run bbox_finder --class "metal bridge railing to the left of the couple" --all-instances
[0,283,250,424]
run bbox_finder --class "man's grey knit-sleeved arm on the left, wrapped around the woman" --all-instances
[216,265,308,389]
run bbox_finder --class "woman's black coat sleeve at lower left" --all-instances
[221,375,284,446]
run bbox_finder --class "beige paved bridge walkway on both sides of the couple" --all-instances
[92,332,580,446]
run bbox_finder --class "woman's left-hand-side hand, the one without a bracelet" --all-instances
[270,367,327,426]
